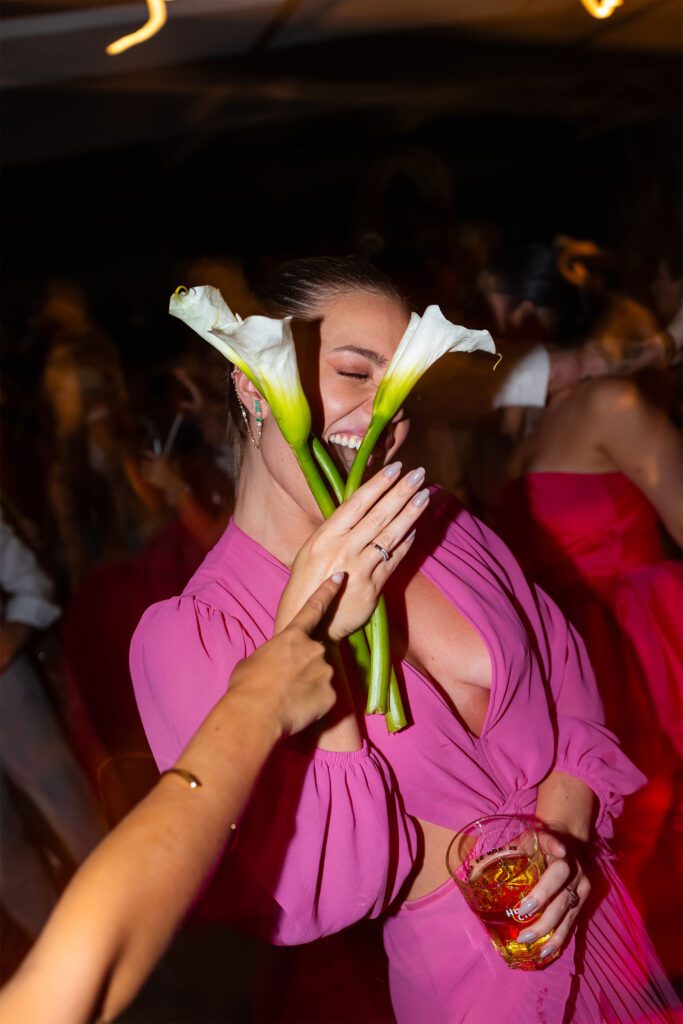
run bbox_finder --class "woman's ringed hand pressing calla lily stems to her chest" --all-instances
[275,463,429,642]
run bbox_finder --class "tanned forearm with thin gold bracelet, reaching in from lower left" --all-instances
[0,693,279,1024]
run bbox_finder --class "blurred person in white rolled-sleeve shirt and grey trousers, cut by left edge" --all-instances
[0,508,104,954]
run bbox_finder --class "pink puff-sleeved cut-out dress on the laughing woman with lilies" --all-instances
[131,494,677,1024]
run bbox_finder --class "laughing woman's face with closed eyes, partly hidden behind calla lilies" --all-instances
[254,292,410,510]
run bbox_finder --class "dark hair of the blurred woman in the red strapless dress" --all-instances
[489,245,601,342]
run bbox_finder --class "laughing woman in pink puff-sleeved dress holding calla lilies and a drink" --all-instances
[131,253,677,1024]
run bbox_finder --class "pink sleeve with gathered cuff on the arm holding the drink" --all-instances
[535,587,646,839]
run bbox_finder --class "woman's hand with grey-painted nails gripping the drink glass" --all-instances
[517,830,591,963]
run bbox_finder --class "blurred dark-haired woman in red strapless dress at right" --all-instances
[496,239,683,973]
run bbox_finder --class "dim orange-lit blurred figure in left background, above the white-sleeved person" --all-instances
[42,282,159,592]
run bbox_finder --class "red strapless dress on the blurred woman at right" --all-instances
[500,472,683,974]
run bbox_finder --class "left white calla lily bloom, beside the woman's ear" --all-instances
[169,286,311,450]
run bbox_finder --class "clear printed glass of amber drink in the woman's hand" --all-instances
[446,814,559,971]
